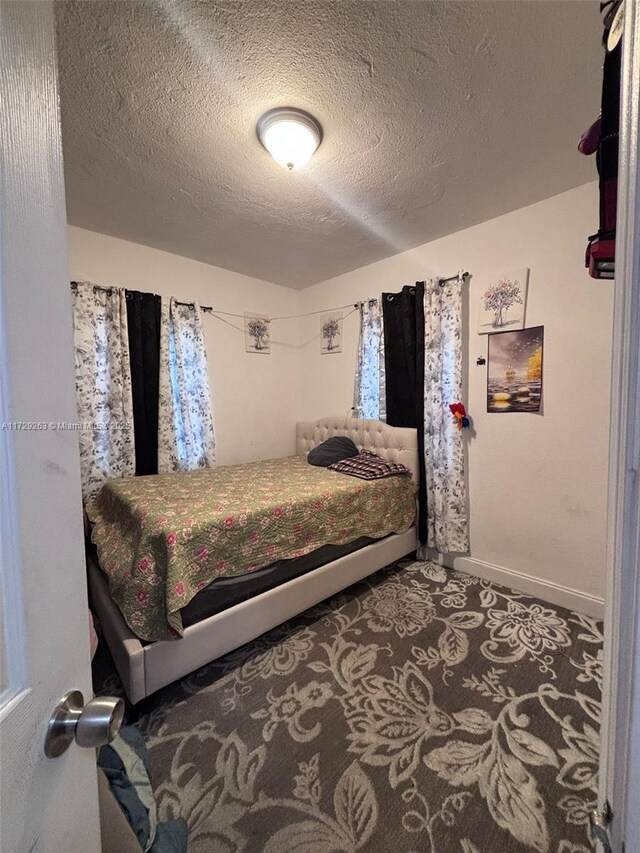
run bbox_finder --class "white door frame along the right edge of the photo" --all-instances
[598,0,640,853]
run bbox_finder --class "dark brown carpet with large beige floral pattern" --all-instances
[92,561,602,853]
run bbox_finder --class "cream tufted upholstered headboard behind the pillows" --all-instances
[296,416,419,483]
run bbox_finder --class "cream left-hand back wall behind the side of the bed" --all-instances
[68,227,299,465]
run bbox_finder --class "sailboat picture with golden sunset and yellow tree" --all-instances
[487,326,544,413]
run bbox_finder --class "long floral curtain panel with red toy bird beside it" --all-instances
[418,279,469,559]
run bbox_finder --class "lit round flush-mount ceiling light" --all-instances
[256,107,322,171]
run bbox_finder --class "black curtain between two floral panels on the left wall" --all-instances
[127,290,161,476]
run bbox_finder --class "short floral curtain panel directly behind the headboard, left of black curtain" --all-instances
[353,299,386,421]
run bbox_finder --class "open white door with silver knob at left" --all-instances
[0,2,100,853]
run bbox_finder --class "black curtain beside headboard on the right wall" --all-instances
[382,281,427,544]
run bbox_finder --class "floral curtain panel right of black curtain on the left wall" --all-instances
[158,298,215,473]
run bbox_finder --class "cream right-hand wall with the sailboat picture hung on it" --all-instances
[299,183,613,612]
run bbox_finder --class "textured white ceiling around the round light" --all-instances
[57,0,602,287]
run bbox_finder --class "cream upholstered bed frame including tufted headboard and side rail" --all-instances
[88,417,419,703]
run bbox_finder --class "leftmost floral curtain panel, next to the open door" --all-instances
[71,282,135,502]
